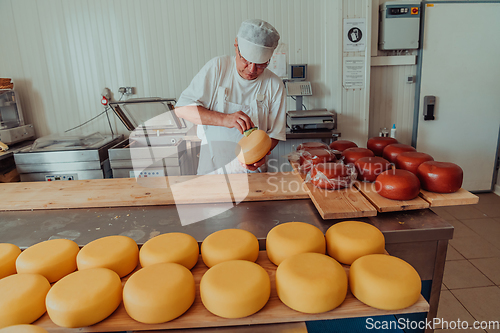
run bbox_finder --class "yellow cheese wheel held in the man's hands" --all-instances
[236,130,272,164]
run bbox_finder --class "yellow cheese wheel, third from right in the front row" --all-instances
[200,260,271,318]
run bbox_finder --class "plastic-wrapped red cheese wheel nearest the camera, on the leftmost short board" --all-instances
[311,163,352,190]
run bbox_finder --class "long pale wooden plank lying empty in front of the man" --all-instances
[0,173,308,210]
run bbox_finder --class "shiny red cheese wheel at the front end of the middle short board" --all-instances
[375,169,420,200]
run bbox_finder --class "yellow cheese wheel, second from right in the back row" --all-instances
[266,222,326,265]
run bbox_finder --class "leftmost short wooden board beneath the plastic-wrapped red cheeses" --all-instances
[290,161,377,220]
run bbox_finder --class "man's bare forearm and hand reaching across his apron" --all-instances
[175,105,254,134]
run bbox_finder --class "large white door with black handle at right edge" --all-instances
[416,2,500,191]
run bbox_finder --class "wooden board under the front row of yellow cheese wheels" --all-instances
[34,251,429,332]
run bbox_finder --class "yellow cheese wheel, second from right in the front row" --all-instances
[276,252,347,313]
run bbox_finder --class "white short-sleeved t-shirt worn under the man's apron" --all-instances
[176,56,286,141]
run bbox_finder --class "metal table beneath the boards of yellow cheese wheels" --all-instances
[0,199,453,330]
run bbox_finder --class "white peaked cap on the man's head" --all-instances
[238,19,280,64]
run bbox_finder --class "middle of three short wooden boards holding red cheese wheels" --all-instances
[354,181,429,213]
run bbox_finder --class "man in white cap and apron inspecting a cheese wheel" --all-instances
[175,19,286,175]
